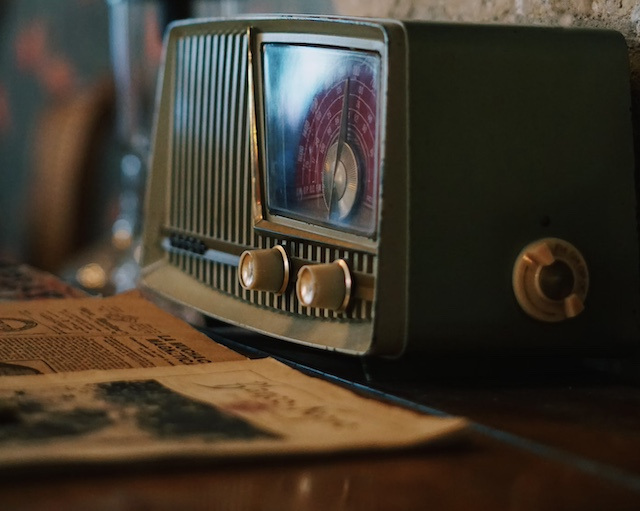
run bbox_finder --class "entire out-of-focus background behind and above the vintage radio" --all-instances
[0,0,640,294]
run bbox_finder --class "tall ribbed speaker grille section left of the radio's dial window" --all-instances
[170,33,253,246]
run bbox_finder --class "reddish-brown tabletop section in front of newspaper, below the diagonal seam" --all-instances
[1,434,640,511]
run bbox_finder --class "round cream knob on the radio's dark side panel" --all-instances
[513,238,589,322]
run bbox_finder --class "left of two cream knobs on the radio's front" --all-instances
[238,245,290,294]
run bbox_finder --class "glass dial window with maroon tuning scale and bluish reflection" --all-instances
[263,43,380,237]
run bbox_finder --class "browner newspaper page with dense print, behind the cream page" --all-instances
[0,291,245,376]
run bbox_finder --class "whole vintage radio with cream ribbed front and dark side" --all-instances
[142,16,640,357]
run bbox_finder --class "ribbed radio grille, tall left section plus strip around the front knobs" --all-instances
[167,31,375,320]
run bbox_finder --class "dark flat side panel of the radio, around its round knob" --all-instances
[407,24,640,354]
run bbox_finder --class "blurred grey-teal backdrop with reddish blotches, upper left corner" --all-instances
[0,0,112,259]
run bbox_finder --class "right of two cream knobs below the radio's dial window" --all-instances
[296,259,353,312]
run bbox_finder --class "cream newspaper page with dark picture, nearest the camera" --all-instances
[0,358,466,469]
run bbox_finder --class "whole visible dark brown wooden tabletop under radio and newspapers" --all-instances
[0,325,640,511]
